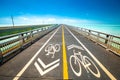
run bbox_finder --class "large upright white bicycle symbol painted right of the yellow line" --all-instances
[69,50,100,78]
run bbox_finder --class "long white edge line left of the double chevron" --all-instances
[13,27,60,80]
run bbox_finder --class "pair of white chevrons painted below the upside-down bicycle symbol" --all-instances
[34,58,60,75]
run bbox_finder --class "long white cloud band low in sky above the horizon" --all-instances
[0,16,98,25]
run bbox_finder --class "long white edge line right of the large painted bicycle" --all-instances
[66,27,117,80]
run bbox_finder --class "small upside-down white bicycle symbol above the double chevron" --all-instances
[45,44,60,58]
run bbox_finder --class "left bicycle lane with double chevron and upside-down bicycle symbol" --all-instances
[13,27,62,80]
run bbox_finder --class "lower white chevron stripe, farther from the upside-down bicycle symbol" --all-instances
[34,62,59,76]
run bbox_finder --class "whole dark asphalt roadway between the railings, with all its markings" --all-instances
[0,25,120,80]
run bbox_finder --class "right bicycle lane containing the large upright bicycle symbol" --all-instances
[64,27,116,80]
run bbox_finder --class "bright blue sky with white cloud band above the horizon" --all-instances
[0,0,120,25]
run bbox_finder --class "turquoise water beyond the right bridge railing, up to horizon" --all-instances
[80,25,120,36]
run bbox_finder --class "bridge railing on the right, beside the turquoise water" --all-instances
[72,28,120,55]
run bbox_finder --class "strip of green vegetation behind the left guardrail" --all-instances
[0,25,51,37]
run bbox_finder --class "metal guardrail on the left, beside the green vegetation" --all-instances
[0,25,59,62]
